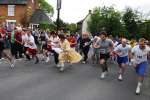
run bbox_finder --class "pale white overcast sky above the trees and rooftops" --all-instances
[46,0,150,23]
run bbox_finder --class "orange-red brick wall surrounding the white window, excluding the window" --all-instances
[0,0,38,24]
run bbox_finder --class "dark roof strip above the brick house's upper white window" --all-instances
[0,0,27,5]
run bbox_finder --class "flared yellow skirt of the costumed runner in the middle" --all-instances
[59,49,82,63]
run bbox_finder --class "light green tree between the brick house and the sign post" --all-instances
[38,0,54,14]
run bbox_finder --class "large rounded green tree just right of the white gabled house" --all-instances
[88,6,122,35]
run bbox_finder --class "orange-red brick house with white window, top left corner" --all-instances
[0,0,39,27]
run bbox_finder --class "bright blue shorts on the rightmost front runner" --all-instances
[136,62,147,76]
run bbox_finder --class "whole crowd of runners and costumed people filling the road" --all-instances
[0,25,150,95]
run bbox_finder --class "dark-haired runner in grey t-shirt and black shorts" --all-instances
[94,32,113,79]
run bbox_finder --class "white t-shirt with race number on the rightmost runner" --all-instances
[132,45,150,64]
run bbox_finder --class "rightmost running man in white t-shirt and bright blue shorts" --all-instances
[131,38,150,95]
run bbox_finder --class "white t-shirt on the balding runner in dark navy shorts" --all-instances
[114,44,131,57]
